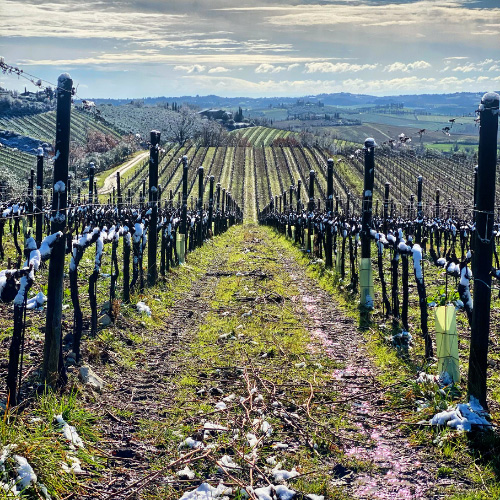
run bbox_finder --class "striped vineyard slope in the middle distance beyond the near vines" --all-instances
[110,143,480,223]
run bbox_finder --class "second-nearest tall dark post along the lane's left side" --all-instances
[148,130,160,286]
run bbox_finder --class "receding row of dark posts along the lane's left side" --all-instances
[37,73,241,387]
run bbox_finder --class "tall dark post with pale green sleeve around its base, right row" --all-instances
[359,137,376,309]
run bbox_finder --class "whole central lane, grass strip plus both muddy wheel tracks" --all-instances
[81,225,468,500]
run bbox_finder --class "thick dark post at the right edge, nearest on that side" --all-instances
[468,92,500,408]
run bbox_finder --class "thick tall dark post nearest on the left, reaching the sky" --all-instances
[42,73,73,387]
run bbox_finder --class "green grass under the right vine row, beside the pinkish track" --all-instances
[270,228,500,500]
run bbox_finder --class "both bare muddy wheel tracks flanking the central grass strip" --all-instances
[75,228,468,500]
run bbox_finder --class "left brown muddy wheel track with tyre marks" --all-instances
[81,261,228,500]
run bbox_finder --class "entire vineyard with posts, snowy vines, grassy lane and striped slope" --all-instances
[0,84,500,500]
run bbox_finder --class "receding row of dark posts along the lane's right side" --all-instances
[265,93,500,408]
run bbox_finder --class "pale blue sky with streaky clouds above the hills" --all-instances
[0,0,500,98]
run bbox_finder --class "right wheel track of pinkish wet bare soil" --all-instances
[284,270,469,500]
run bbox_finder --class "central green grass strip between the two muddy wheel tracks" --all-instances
[124,226,363,499]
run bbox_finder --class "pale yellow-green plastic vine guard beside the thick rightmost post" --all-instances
[435,305,460,384]
